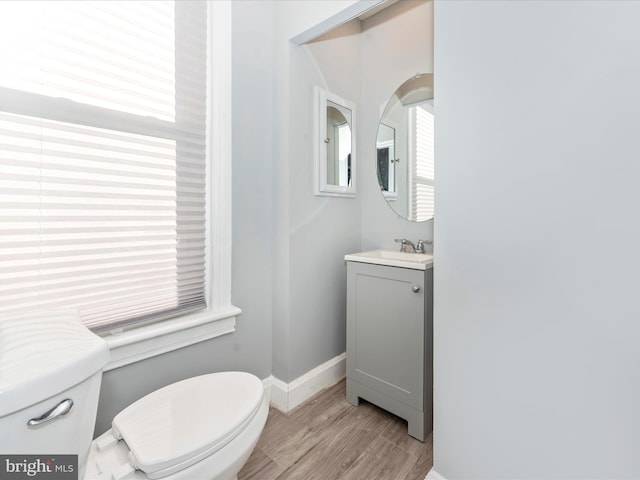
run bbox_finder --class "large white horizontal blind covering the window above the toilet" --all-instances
[0,0,207,328]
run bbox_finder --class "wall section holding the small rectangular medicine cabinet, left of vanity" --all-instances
[282,23,360,381]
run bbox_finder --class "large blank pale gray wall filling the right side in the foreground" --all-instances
[434,1,640,480]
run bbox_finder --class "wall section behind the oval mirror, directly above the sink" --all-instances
[358,0,438,250]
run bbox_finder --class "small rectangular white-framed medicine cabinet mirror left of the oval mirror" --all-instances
[314,87,356,197]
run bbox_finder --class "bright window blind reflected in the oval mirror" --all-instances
[409,103,434,222]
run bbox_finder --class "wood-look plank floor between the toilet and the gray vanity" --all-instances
[238,380,433,480]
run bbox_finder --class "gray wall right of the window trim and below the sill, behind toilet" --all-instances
[95,1,274,434]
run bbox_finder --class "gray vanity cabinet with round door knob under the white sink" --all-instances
[347,261,433,440]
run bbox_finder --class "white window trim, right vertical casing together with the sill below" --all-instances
[100,0,241,371]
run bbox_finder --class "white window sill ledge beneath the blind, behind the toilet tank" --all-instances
[104,305,241,371]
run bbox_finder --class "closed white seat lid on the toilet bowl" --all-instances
[112,372,264,478]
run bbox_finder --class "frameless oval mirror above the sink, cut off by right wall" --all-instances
[376,73,434,222]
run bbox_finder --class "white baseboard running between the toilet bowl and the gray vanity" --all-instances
[263,353,347,413]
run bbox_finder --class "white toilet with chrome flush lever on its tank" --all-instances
[0,310,269,480]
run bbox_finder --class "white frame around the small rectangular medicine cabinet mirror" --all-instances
[313,87,357,198]
